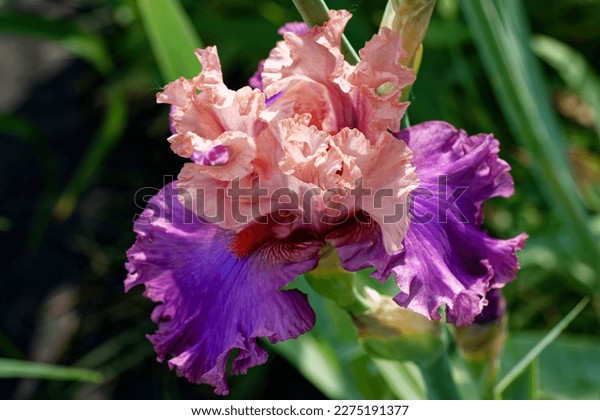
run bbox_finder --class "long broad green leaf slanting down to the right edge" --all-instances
[461,0,600,292]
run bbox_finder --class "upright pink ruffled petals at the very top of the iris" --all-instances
[261,11,415,143]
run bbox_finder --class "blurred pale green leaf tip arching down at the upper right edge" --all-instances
[531,35,600,135]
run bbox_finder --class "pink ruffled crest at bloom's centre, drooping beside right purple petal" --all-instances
[277,117,418,254]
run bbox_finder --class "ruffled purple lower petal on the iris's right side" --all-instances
[328,122,527,326]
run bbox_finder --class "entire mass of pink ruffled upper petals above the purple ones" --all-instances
[158,11,418,249]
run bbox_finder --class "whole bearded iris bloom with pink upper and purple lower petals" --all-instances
[125,11,525,394]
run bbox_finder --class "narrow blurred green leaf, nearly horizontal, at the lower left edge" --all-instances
[0,358,103,383]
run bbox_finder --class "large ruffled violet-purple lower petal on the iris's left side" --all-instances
[125,184,322,394]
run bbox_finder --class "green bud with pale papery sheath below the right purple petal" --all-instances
[353,288,445,365]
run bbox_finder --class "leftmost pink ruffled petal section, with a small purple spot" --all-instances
[157,47,267,223]
